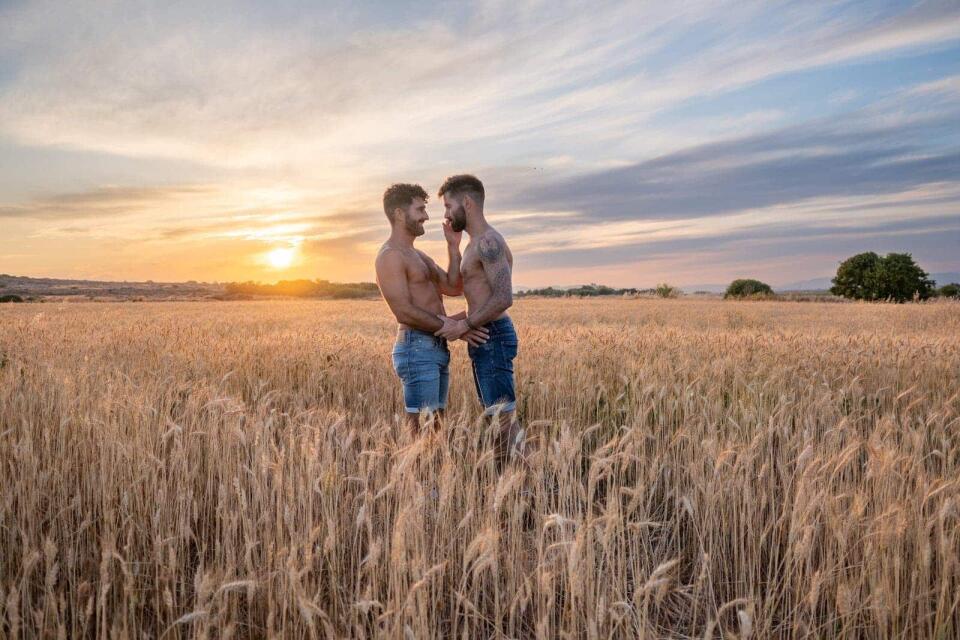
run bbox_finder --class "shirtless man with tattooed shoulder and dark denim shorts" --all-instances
[435,175,522,465]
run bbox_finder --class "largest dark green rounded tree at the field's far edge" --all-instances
[830,251,934,302]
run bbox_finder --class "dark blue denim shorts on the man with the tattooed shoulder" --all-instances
[467,318,519,415]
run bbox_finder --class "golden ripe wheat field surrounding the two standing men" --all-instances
[0,299,960,639]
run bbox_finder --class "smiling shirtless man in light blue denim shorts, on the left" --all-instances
[376,184,487,433]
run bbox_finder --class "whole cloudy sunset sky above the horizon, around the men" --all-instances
[0,0,960,286]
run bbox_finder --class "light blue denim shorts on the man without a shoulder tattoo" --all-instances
[393,329,450,413]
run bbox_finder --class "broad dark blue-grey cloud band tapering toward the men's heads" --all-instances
[507,105,960,224]
